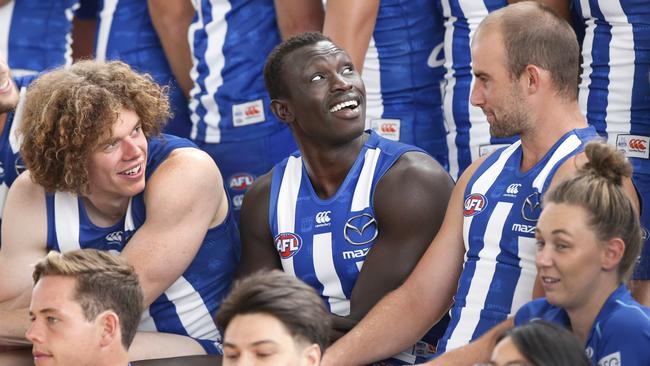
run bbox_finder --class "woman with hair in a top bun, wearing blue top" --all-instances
[432,143,650,365]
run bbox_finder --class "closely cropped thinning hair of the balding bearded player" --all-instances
[479,1,580,100]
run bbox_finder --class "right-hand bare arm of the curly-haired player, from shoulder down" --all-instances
[122,149,228,307]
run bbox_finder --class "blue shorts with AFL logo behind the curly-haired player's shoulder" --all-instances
[192,125,298,225]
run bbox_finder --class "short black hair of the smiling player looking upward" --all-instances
[264,32,332,99]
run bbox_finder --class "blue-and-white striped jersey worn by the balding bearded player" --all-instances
[438,127,597,350]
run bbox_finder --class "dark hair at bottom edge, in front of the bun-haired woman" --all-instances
[499,320,591,366]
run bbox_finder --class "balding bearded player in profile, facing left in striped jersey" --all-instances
[323,2,633,365]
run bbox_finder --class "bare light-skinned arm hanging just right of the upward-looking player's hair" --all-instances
[323,0,379,72]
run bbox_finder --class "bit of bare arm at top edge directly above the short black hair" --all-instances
[275,0,325,40]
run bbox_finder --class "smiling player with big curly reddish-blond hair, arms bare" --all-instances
[0,61,239,360]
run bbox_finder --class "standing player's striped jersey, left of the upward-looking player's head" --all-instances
[189,0,287,144]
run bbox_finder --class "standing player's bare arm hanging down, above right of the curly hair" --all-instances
[147,0,194,98]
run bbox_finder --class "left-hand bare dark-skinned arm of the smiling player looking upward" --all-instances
[237,172,282,278]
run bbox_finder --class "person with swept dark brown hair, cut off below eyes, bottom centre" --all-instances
[217,271,330,366]
